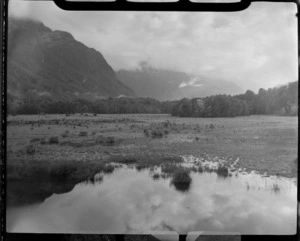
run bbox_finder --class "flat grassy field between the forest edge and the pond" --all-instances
[7,114,298,204]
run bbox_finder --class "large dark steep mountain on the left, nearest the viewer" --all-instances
[7,18,134,100]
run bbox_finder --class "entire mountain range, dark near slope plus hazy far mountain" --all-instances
[7,18,242,101]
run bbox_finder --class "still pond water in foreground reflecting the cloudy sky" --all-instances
[7,166,297,234]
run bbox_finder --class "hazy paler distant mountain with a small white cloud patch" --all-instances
[117,65,243,101]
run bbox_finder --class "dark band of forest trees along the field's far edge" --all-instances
[7,81,298,117]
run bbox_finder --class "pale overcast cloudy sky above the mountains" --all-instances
[9,0,298,91]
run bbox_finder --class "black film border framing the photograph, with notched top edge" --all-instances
[0,0,300,241]
